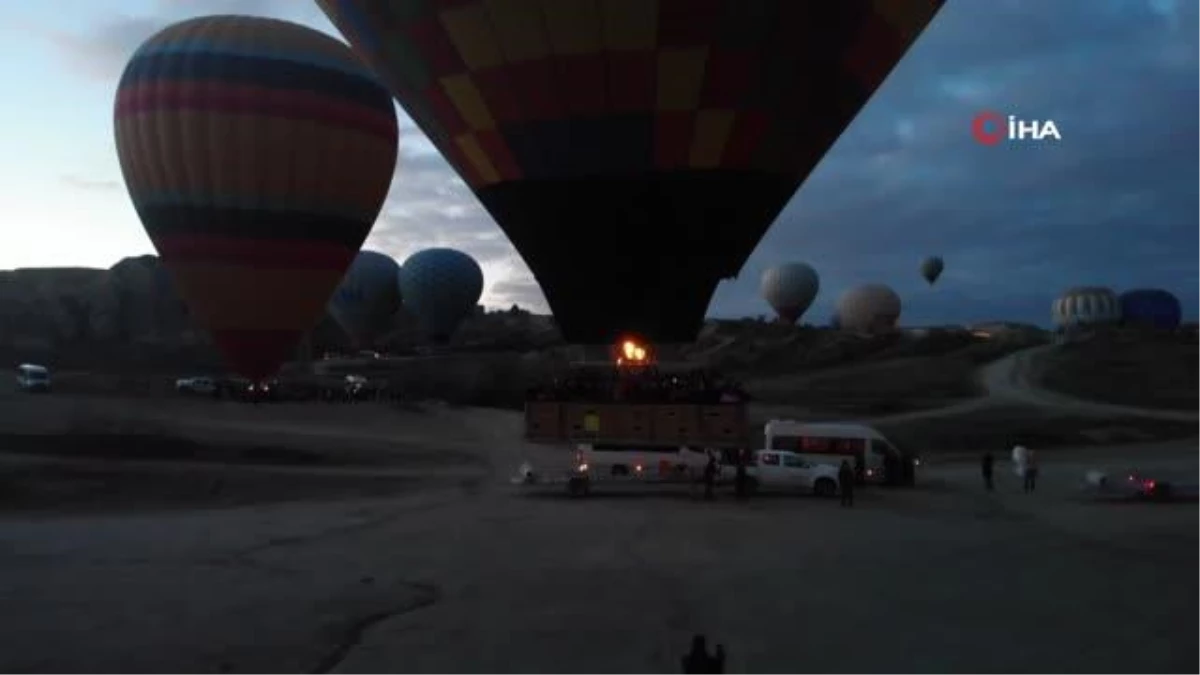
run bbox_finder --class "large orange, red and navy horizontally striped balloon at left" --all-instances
[115,16,397,381]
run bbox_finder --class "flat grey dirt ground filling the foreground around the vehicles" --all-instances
[0,389,1200,675]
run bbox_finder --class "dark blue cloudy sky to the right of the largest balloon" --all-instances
[713,0,1200,323]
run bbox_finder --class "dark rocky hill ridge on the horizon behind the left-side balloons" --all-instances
[0,256,559,369]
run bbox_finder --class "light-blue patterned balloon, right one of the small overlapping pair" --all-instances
[400,249,484,342]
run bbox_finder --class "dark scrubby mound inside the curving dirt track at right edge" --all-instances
[1043,333,1200,410]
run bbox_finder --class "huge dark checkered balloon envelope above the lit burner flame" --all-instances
[317,0,943,345]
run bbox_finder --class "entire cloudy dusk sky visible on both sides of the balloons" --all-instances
[0,0,1200,324]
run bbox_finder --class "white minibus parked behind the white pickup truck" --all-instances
[764,419,916,483]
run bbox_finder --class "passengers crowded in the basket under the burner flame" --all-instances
[528,366,748,404]
